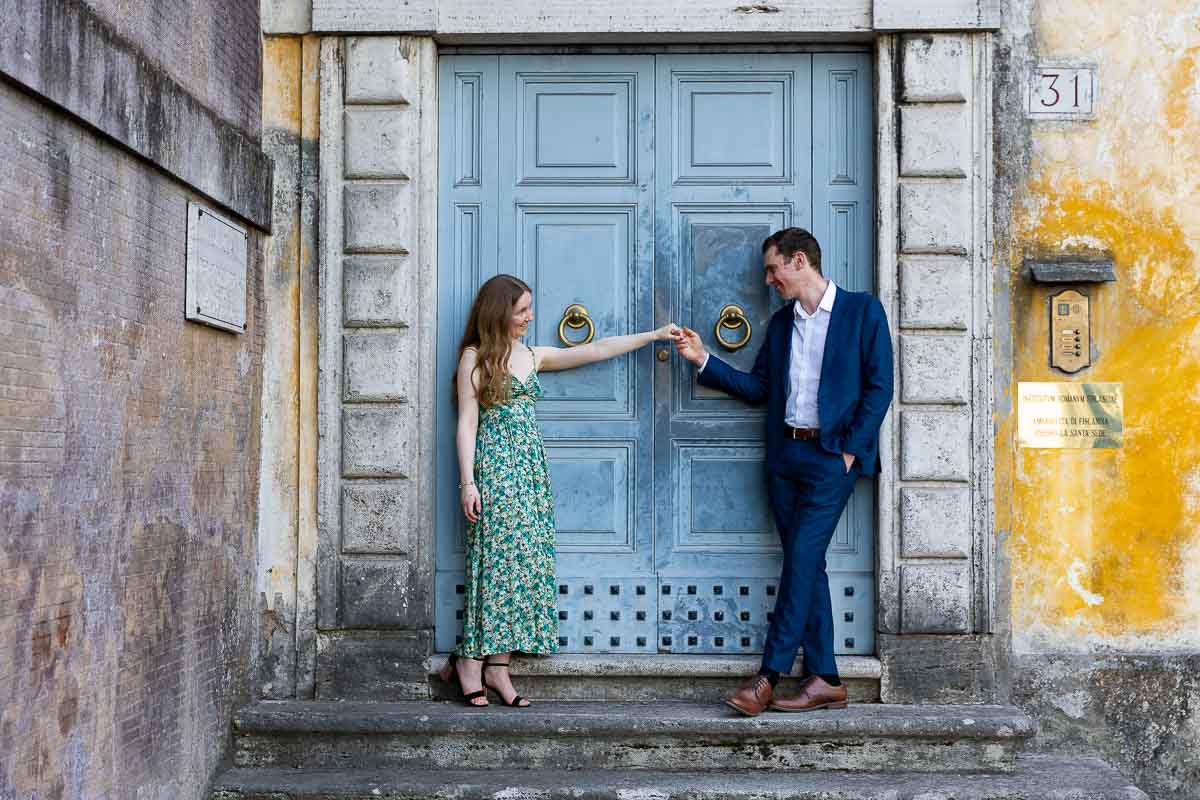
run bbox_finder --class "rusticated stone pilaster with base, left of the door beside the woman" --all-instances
[317,36,437,697]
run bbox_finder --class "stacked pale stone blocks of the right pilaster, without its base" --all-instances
[898,35,991,633]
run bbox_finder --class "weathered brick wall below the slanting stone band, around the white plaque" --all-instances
[0,77,263,800]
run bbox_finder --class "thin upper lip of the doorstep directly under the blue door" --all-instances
[430,652,883,680]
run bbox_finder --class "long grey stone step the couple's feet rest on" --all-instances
[234,700,1037,772]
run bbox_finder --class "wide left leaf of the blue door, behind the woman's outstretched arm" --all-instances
[498,55,654,606]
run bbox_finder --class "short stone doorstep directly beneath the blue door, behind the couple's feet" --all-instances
[430,655,882,703]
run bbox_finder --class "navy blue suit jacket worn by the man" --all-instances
[698,287,893,475]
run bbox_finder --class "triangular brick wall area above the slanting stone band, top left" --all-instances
[84,0,263,138]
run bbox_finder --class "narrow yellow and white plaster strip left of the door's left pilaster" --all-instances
[257,36,320,697]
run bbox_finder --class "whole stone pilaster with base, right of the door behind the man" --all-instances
[881,34,995,702]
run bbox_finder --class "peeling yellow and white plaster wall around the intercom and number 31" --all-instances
[996,0,1200,652]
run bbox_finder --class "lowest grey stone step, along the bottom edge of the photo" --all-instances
[209,756,1147,800]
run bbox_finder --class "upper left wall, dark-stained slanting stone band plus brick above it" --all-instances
[0,0,271,229]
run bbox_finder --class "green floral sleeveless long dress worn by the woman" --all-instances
[456,362,558,656]
